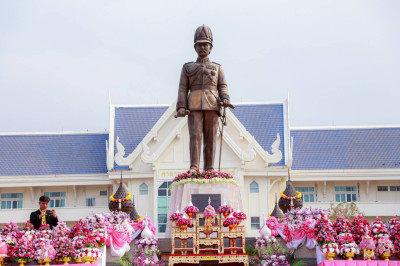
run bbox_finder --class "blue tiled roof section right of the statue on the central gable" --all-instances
[232,104,285,166]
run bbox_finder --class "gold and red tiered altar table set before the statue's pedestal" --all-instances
[168,213,249,265]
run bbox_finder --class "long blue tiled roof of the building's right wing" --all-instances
[291,127,400,170]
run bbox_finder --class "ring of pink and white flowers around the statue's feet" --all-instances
[172,170,238,186]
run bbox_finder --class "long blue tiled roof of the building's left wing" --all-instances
[0,133,108,176]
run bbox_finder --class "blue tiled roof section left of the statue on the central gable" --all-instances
[114,106,168,169]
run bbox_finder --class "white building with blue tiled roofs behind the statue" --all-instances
[0,101,400,237]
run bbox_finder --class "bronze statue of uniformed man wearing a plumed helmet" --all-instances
[176,25,232,171]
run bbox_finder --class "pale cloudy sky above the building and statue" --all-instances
[0,0,400,133]
